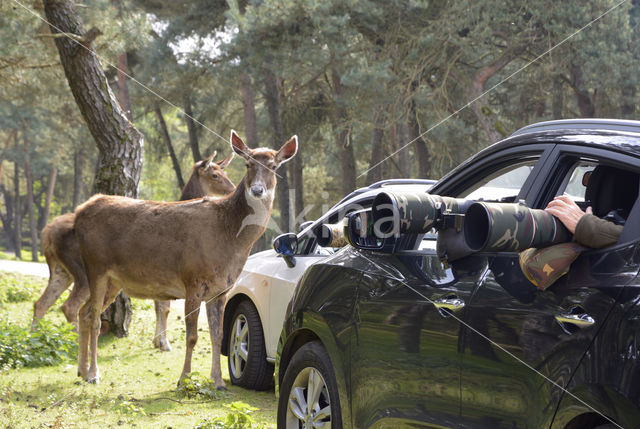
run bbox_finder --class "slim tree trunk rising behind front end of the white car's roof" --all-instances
[331,68,356,196]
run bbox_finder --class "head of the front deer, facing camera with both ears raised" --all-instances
[231,130,298,199]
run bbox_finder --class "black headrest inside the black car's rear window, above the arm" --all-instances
[585,165,639,219]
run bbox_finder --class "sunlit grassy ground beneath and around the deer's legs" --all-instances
[0,272,276,429]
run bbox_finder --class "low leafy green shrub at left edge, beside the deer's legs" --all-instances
[0,316,78,371]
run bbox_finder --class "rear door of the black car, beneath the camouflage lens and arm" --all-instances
[460,145,637,428]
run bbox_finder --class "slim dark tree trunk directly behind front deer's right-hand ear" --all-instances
[264,70,291,232]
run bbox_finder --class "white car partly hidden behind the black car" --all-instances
[222,179,435,390]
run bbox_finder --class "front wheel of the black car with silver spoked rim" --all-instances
[278,341,342,429]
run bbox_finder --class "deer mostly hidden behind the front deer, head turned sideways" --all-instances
[31,152,235,351]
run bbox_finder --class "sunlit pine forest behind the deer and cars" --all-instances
[0,0,640,258]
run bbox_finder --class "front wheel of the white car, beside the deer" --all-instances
[227,301,273,390]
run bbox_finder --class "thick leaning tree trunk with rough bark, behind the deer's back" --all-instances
[43,0,143,336]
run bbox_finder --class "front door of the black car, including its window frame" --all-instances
[351,145,553,428]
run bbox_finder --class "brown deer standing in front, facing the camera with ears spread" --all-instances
[75,131,298,389]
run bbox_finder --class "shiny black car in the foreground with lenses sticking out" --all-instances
[276,120,640,428]
